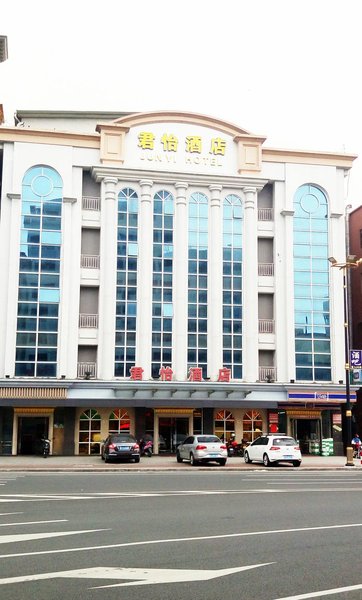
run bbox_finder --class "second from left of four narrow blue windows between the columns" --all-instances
[151,190,174,377]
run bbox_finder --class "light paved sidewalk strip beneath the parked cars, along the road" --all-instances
[0,454,362,473]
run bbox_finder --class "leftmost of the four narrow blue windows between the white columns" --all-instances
[114,188,138,377]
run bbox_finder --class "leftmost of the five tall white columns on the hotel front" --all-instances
[98,177,118,379]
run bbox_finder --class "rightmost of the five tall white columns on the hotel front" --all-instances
[243,187,259,382]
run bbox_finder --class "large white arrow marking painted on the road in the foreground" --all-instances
[0,563,274,589]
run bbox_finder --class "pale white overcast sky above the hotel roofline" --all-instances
[0,0,362,207]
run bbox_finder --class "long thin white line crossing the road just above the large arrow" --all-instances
[0,523,362,558]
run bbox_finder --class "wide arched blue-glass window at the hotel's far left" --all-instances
[15,166,63,377]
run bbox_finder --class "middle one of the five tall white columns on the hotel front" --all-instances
[172,181,188,381]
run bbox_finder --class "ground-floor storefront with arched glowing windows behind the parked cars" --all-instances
[0,394,343,455]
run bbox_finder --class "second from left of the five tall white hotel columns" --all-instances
[136,179,153,379]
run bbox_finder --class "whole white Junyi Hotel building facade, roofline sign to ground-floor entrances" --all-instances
[0,111,355,454]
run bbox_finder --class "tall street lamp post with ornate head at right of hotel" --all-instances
[328,255,362,467]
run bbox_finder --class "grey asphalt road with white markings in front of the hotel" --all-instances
[0,468,362,600]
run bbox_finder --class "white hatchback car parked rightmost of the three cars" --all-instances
[244,434,302,467]
